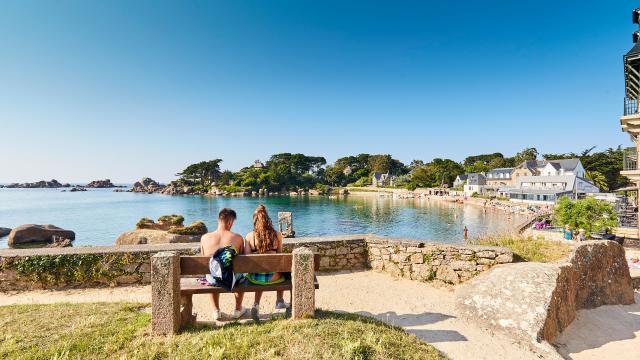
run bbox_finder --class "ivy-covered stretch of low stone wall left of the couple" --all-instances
[0,244,199,291]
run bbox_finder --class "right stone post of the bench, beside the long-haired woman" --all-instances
[291,247,316,319]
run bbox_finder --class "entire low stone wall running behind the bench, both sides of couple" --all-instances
[0,235,513,291]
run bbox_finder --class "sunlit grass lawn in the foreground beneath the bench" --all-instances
[0,303,446,359]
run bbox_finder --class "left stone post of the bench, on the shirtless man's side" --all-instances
[151,252,180,335]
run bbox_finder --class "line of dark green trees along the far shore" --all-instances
[176,146,629,191]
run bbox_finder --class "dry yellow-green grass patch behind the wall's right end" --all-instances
[469,234,572,263]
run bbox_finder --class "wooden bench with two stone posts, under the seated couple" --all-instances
[151,248,320,335]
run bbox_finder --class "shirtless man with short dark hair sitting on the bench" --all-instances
[200,208,247,320]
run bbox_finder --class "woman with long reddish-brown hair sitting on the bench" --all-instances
[244,204,289,321]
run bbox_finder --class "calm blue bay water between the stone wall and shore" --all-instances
[0,189,523,247]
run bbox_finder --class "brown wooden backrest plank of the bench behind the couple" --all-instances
[180,254,320,275]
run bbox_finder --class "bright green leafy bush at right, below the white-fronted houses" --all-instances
[554,196,618,235]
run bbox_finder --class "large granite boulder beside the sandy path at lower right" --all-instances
[456,241,634,356]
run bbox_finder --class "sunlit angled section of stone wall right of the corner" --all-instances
[367,236,513,284]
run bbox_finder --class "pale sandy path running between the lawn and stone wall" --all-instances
[0,271,640,360]
